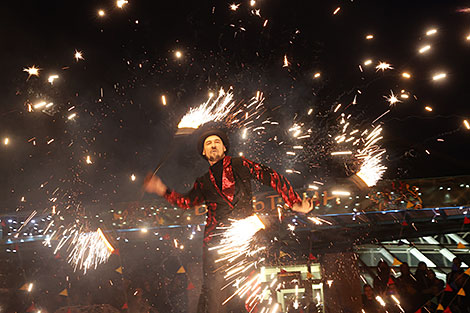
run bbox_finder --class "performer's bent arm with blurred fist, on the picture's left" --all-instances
[144,173,204,209]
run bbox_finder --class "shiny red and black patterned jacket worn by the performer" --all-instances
[164,156,302,243]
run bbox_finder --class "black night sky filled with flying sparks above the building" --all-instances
[0,0,470,212]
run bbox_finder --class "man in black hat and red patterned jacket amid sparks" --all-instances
[144,129,312,313]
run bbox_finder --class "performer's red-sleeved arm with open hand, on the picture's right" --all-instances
[242,158,313,213]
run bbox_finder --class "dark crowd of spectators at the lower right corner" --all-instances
[362,258,470,313]
